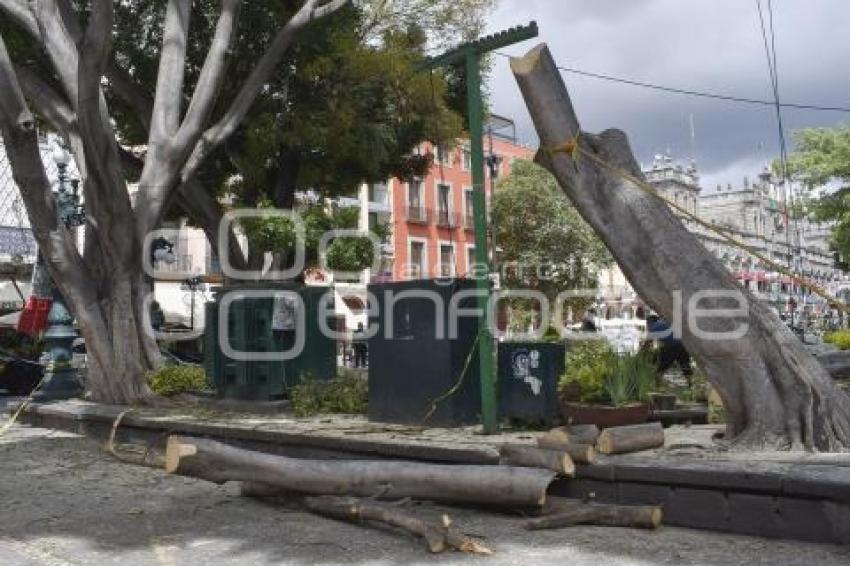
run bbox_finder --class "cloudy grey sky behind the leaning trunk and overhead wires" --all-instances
[489,0,850,190]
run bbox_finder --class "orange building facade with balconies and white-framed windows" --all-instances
[384,134,533,281]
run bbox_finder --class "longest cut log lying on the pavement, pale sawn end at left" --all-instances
[165,436,555,507]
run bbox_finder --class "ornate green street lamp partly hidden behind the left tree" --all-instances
[33,145,86,401]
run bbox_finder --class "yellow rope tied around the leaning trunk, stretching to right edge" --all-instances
[543,134,850,313]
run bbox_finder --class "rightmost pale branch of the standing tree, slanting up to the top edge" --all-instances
[181,0,348,180]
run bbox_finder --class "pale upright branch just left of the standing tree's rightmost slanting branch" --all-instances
[174,0,242,151]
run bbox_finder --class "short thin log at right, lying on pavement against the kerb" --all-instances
[524,499,663,530]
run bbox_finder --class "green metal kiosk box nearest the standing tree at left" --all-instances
[204,284,336,400]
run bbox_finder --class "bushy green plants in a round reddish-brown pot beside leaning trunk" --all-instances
[558,340,657,428]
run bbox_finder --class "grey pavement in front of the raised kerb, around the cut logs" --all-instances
[0,425,850,566]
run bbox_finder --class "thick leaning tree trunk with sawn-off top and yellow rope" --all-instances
[511,45,850,451]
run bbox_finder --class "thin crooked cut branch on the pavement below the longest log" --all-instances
[303,495,492,554]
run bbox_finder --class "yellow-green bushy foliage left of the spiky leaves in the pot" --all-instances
[558,340,617,403]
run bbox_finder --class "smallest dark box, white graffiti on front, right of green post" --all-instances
[498,342,566,425]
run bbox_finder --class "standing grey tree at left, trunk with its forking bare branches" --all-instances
[0,0,347,403]
